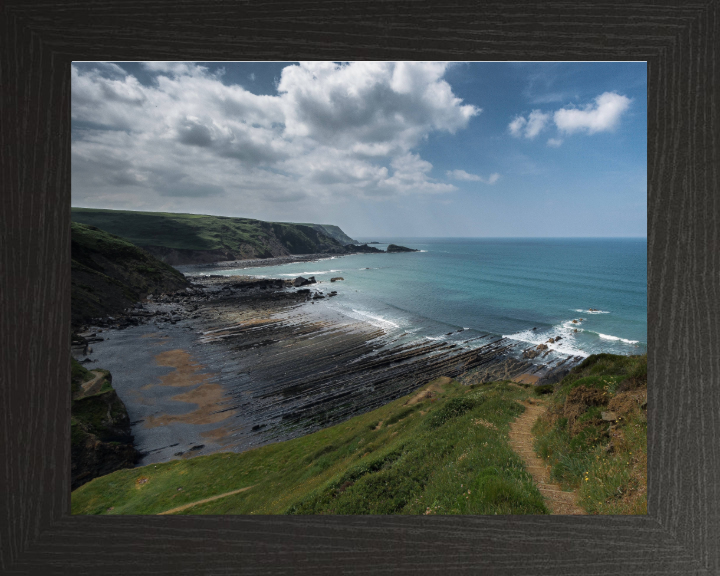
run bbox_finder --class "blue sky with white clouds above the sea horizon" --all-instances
[71,62,647,238]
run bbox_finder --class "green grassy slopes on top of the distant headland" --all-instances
[71,208,346,257]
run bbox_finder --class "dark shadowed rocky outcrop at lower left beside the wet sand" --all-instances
[70,359,140,490]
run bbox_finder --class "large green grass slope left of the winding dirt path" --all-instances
[72,379,547,514]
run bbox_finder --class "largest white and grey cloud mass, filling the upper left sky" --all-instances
[72,62,478,207]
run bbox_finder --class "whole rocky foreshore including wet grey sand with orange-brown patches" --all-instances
[76,272,580,466]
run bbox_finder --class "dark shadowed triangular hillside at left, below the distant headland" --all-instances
[71,222,189,327]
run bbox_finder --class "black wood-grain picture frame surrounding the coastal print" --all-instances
[0,0,720,576]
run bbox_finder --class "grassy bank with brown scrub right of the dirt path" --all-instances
[533,354,647,514]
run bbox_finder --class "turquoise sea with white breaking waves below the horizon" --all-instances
[204,238,647,356]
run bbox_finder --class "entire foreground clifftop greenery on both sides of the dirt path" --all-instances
[72,354,647,514]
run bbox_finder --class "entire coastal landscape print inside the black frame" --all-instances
[71,62,647,515]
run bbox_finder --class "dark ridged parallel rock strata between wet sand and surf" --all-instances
[79,275,584,464]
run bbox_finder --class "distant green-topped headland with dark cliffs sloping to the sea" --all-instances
[72,208,352,265]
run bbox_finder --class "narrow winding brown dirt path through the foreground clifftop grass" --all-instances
[509,401,586,515]
